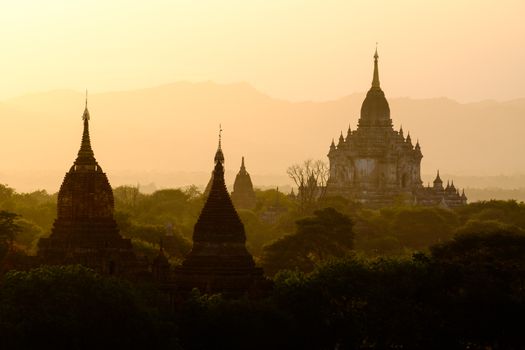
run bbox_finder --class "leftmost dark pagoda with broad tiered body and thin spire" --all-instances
[38,99,137,275]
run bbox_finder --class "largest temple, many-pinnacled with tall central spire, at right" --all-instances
[326,50,467,207]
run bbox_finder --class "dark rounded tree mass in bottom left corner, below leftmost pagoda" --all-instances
[0,265,175,349]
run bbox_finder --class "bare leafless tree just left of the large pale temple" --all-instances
[286,159,329,213]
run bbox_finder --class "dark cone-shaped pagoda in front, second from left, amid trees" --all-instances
[173,136,269,297]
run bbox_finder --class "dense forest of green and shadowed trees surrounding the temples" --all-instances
[0,186,525,349]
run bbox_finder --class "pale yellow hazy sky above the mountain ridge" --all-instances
[0,0,525,101]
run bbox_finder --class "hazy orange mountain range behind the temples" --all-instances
[0,82,525,188]
